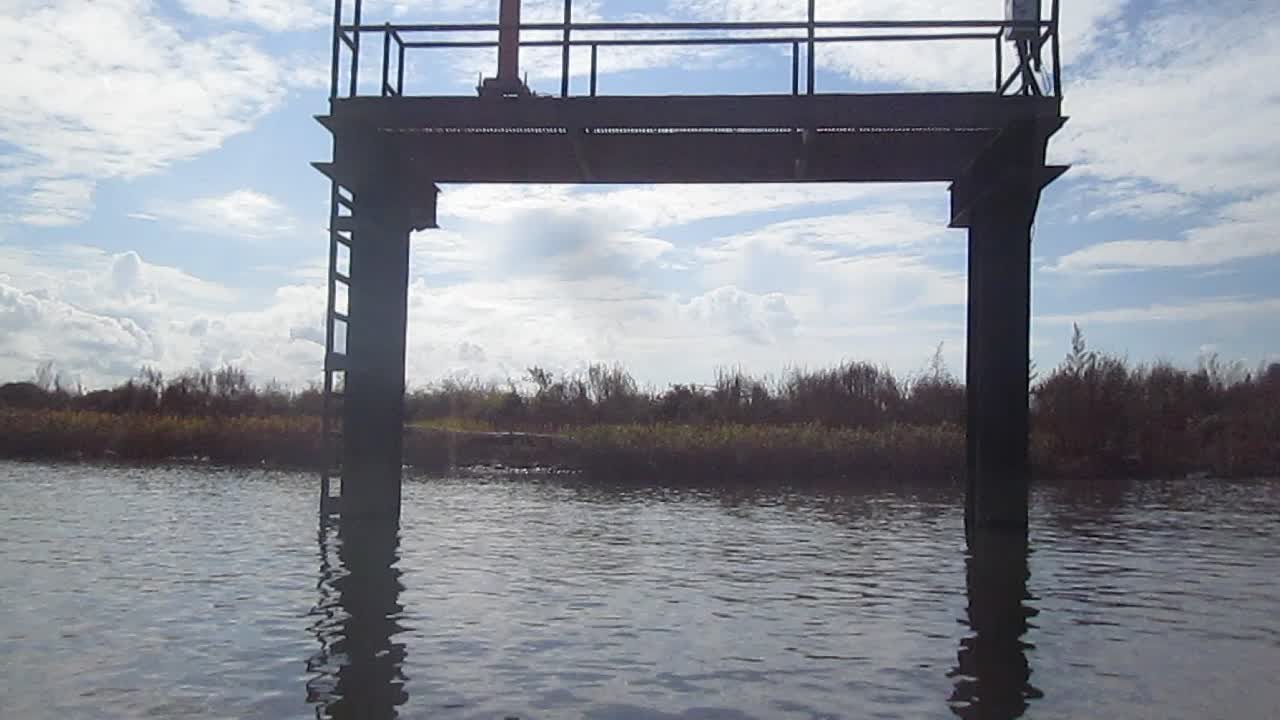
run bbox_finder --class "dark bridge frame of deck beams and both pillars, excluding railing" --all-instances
[316,94,1064,533]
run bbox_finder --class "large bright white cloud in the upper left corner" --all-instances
[0,0,288,224]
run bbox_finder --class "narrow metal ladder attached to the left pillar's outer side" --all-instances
[320,182,355,516]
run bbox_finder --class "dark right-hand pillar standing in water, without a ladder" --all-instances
[965,192,1039,534]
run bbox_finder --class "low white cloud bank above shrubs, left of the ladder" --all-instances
[0,242,325,387]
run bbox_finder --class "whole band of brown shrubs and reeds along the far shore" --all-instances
[0,326,1280,483]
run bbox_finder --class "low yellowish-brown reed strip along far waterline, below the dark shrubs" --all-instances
[0,409,1280,486]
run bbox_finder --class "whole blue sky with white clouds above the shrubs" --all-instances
[0,0,1280,388]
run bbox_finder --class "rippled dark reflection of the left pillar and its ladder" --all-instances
[307,521,408,720]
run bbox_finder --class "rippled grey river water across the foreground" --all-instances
[0,462,1280,719]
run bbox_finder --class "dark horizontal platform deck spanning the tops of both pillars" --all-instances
[319,92,1061,188]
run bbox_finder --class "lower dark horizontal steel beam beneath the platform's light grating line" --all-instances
[325,129,1013,184]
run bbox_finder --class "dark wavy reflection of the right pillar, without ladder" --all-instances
[950,534,1043,720]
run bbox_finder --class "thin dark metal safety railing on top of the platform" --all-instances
[329,0,1062,99]
